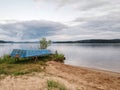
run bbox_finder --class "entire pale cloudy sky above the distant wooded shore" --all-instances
[0,0,120,41]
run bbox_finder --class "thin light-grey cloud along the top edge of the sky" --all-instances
[34,0,120,10]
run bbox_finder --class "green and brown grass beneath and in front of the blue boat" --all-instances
[0,54,65,76]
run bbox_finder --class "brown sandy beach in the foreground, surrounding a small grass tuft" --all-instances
[0,61,120,90]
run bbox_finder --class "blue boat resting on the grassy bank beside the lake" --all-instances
[10,49,52,58]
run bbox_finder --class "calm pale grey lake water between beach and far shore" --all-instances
[0,43,120,72]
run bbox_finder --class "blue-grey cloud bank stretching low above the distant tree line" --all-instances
[0,19,120,41]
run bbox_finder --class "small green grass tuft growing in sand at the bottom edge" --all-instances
[47,80,67,90]
